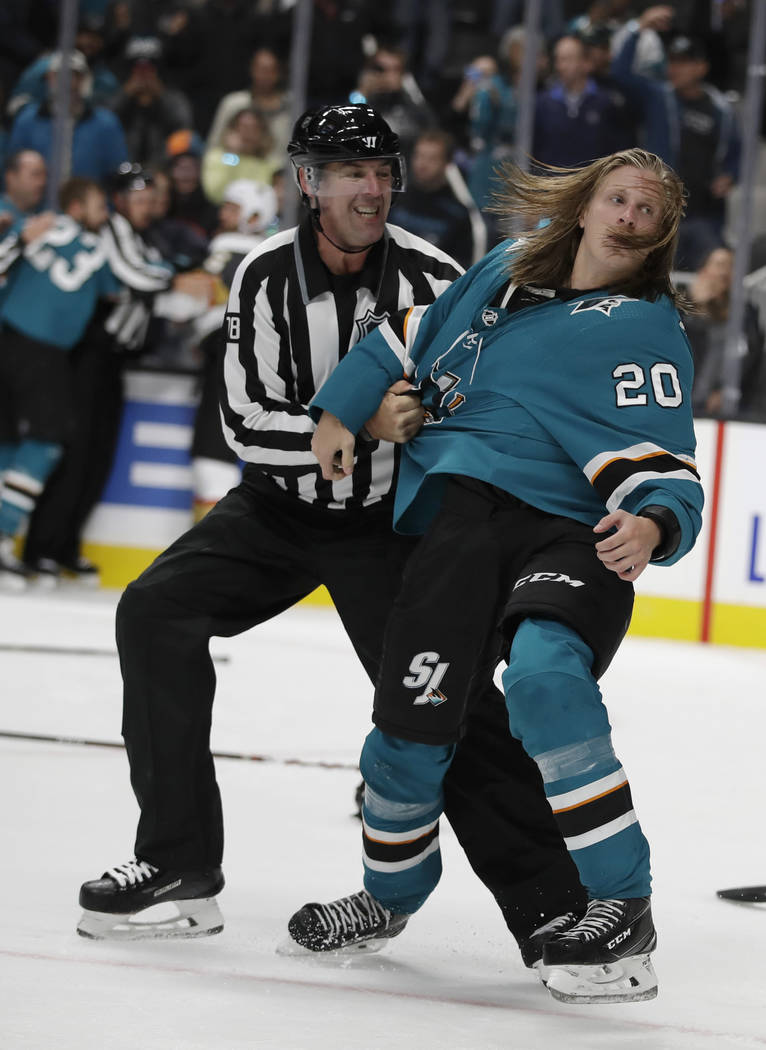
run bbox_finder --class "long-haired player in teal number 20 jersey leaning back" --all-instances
[290,149,702,1002]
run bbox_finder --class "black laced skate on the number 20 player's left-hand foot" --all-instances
[288,889,409,951]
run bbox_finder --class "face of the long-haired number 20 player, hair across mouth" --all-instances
[572,166,662,288]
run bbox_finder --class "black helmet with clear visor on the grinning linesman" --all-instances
[288,103,405,203]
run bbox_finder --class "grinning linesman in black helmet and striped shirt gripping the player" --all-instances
[78,105,584,965]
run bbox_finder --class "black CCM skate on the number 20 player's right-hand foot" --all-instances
[542,897,657,1003]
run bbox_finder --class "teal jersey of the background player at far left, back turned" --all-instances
[0,215,122,350]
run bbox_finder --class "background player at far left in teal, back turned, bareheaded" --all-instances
[0,176,120,590]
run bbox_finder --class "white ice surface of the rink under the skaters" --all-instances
[0,591,766,1050]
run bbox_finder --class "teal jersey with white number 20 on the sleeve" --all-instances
[311,242,703,564]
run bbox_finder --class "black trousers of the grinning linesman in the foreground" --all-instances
[116,470,584,942]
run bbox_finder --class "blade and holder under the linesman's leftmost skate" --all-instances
[77,897,224,941]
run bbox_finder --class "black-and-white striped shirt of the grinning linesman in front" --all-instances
[221,218,463,509]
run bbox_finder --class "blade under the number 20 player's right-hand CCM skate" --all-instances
[545,954,657,1004]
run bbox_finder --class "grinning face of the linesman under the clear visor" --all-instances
[317,160,391,248]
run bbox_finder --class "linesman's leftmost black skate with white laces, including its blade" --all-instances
[77,860,224,940]
